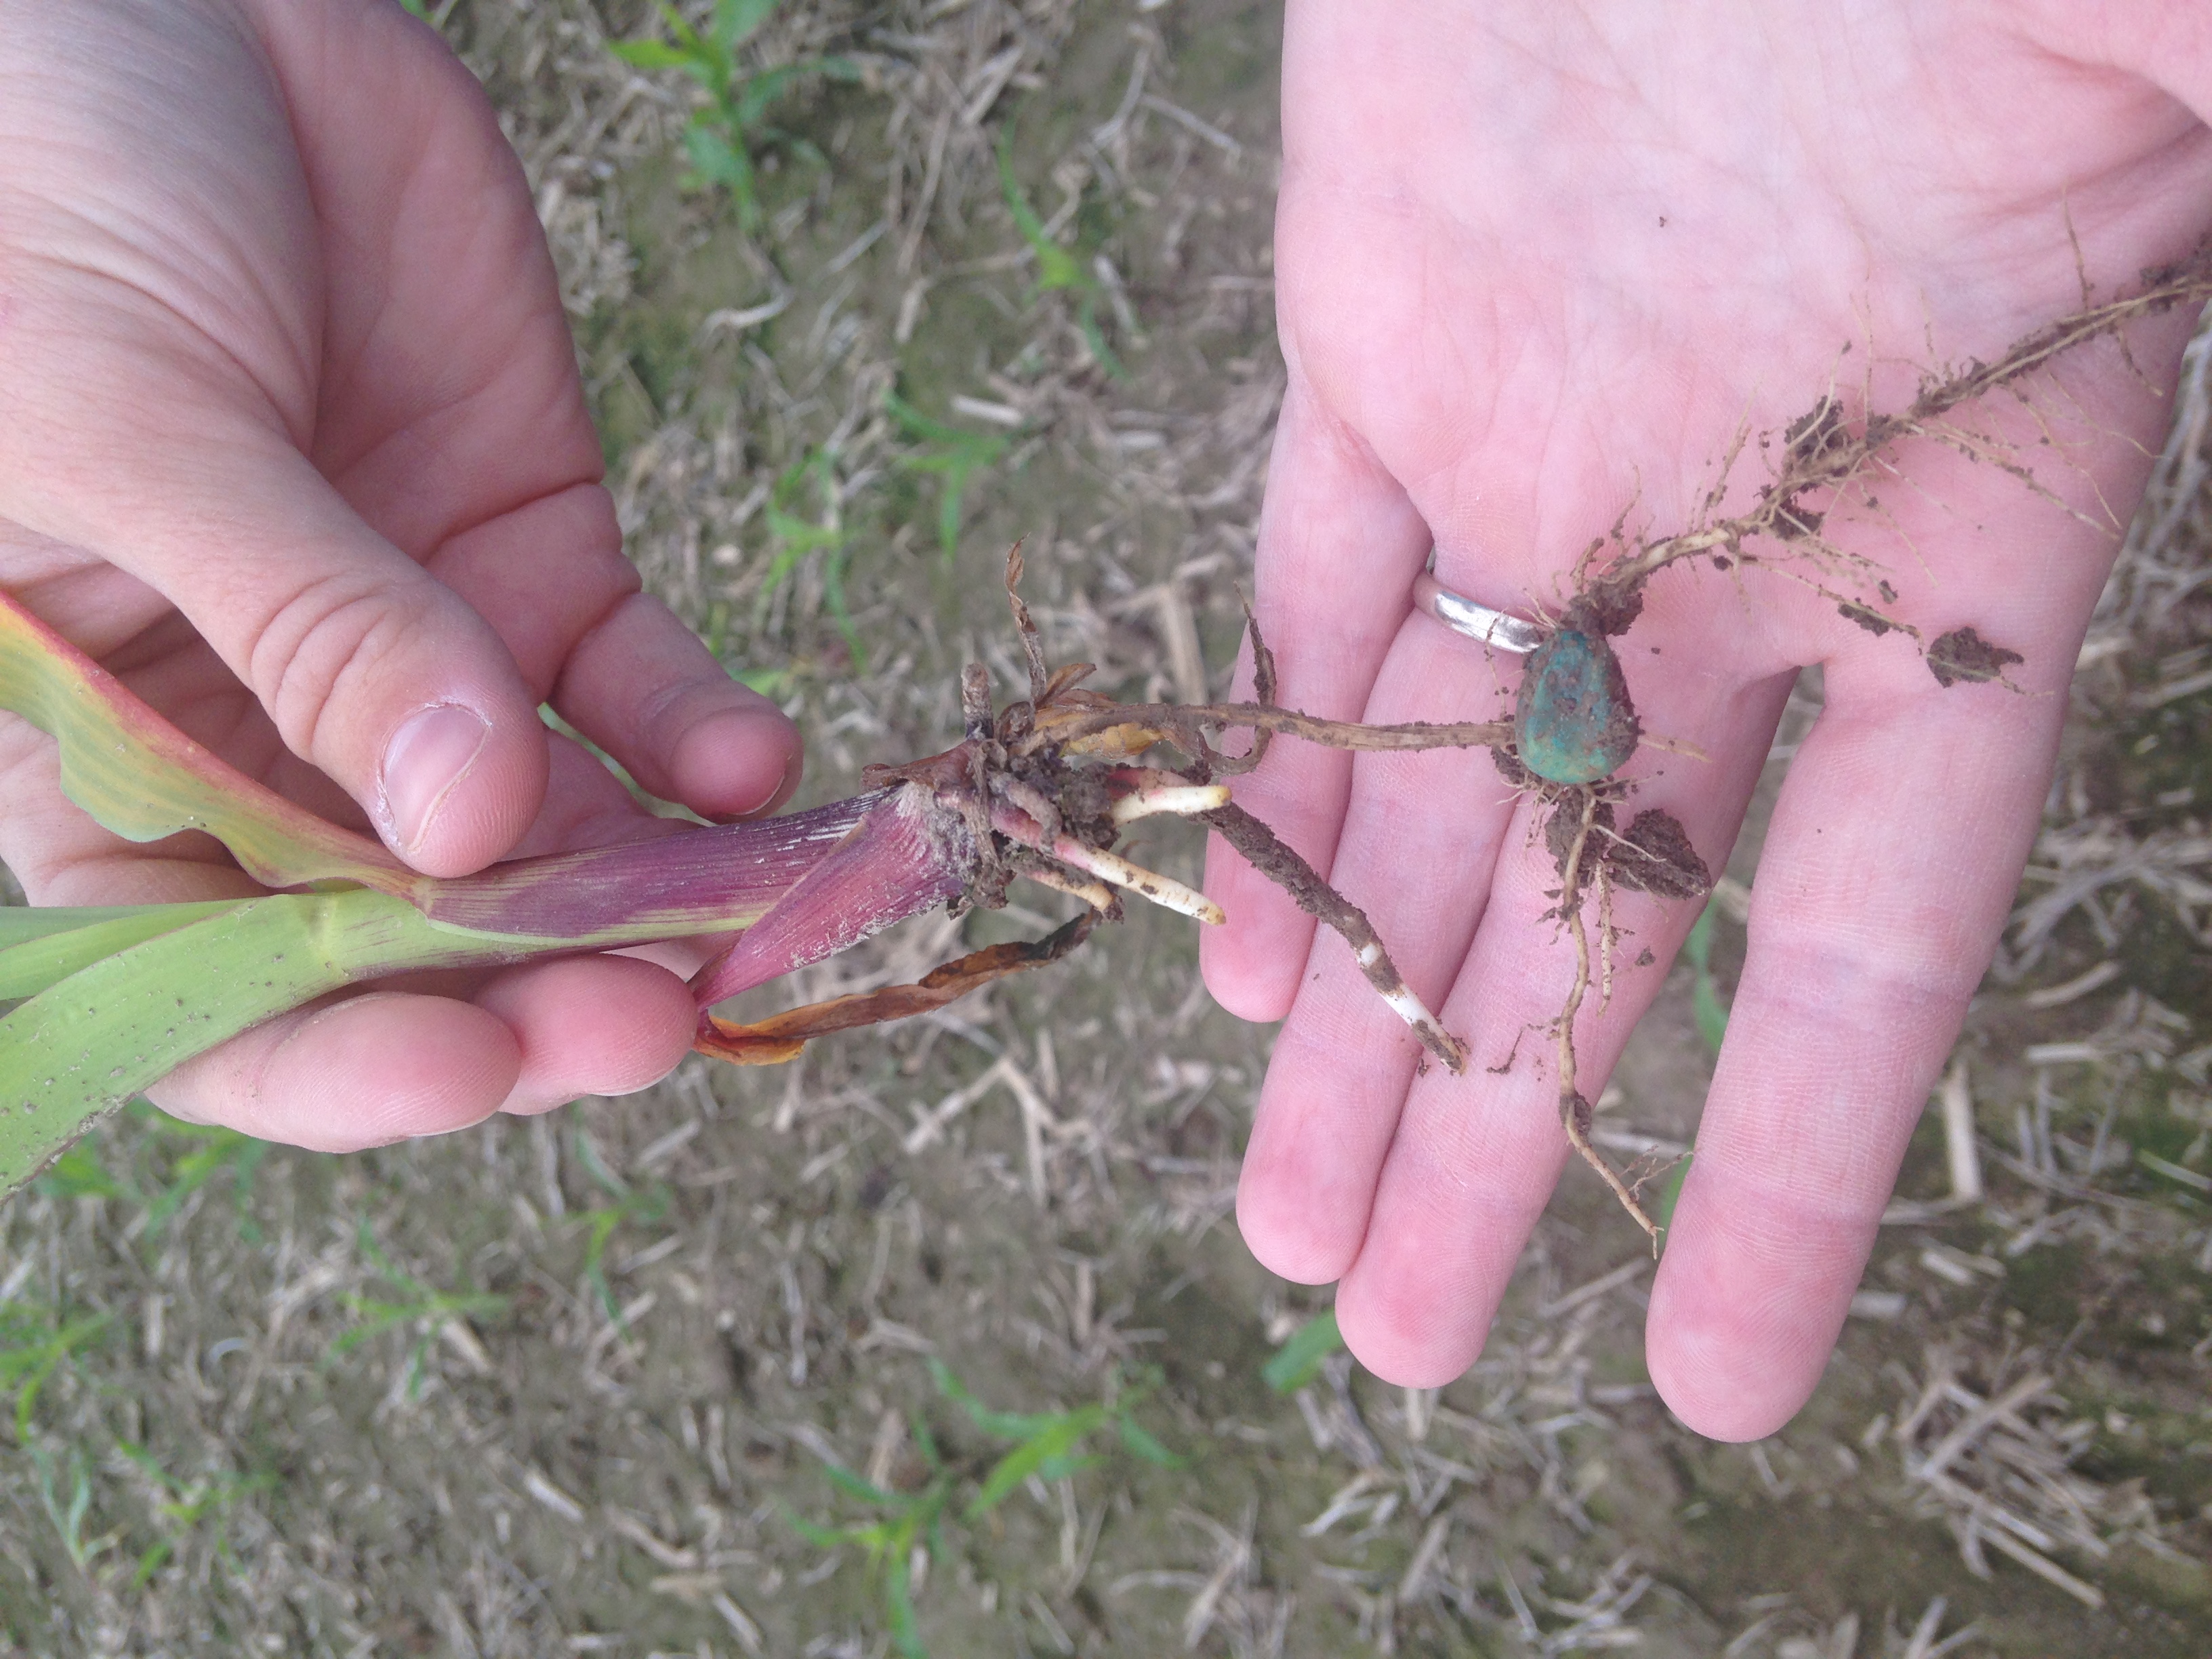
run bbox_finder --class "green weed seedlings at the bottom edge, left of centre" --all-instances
[790,1358,1183,1659]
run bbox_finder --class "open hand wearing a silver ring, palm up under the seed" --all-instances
[1206,0,2212,1438]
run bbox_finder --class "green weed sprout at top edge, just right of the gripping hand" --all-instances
[609,0,861,230]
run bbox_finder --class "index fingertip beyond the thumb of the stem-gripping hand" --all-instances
[553,593,801,819]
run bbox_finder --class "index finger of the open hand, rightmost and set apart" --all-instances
[1648,655,2086,1440]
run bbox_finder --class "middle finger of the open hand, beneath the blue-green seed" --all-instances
[1336,641,1792,1387]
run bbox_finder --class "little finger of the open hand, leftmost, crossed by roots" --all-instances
[1199,376,1429,1020]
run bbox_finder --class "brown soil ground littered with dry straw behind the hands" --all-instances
[0,0,2212,1659]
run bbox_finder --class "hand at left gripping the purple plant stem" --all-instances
[0,0,798,1150]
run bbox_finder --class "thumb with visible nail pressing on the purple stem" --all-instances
[11,418,546,876]
